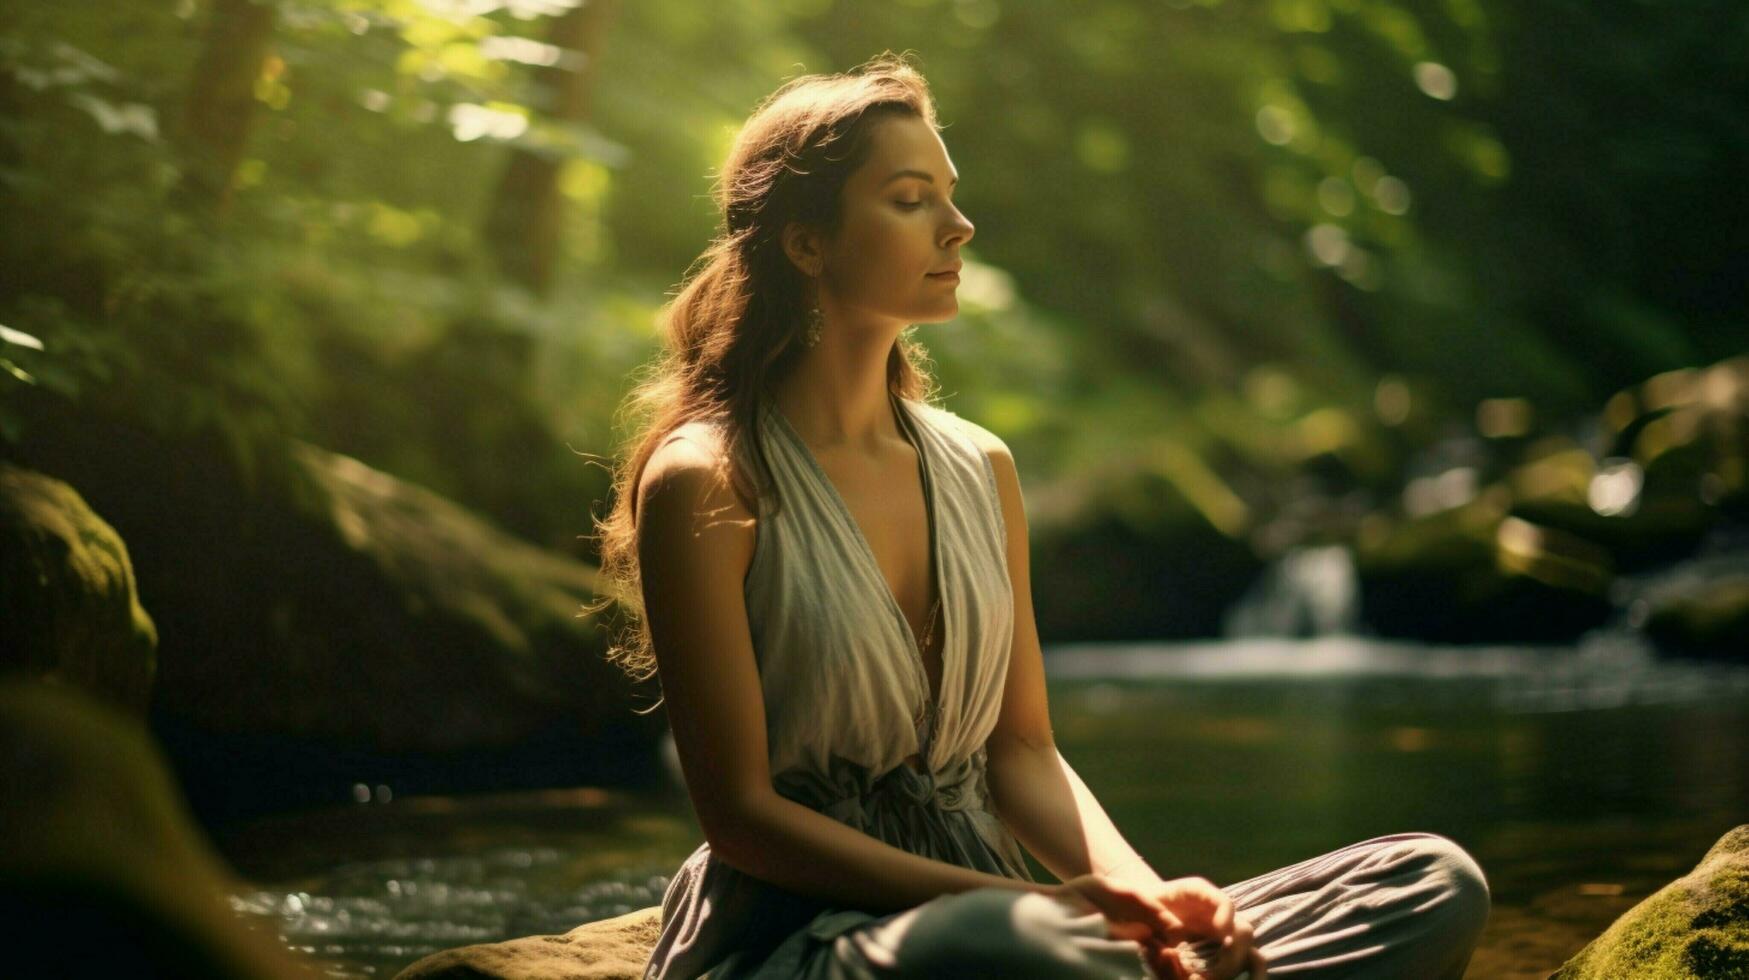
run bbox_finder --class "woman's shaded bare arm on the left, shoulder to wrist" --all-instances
[638,432,1055,912]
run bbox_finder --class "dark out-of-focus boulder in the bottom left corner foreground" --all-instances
[0,677,324,980]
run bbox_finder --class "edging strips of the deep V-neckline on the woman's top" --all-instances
[766,392,953,749]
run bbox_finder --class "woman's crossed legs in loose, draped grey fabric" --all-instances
[799,833,1488,980]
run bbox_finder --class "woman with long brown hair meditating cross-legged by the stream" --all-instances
[603,54,1488,980]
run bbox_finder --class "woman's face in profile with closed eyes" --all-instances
[820,116,972,324]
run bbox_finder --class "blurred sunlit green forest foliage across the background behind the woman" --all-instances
[0,0,1749,563]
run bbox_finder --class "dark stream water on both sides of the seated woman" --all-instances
[219,635,1749,978]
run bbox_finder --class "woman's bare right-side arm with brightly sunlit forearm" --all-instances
[972,425,1160,884]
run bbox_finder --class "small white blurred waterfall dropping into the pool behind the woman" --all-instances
[1223,544,1361,639]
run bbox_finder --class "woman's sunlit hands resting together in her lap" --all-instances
[1056,875,1268,980]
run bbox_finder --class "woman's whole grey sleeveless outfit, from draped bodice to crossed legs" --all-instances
[644,397,1490,980]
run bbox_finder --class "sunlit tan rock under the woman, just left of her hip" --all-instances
[395,905,661,980]
